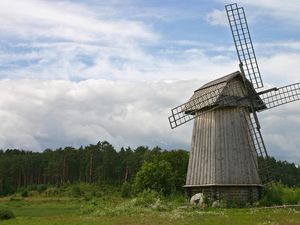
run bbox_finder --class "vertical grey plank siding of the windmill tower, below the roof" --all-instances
[186,107,261,186]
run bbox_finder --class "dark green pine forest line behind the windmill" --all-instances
[0,141,300,195]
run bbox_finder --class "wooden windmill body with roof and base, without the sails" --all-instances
[185,72,261,200]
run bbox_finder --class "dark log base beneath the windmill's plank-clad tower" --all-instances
[184,185,261,203]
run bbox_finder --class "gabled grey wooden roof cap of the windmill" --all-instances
[185,71,265,114]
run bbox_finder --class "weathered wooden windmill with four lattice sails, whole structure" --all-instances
[169,3,300,201]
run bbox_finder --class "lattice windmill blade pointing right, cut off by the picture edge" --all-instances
[260,83,300,110]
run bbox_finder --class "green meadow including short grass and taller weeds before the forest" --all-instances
[0,186,300,225]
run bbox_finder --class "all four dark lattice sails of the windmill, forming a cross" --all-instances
[169,4,300,183]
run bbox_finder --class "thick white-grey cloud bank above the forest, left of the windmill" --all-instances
[0,80,195,150]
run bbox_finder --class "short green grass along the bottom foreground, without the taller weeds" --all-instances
[0,197,300,225]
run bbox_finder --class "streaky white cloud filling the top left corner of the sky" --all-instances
[0,0,158,42]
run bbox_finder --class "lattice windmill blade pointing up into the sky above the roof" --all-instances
[225,3,264,89]
